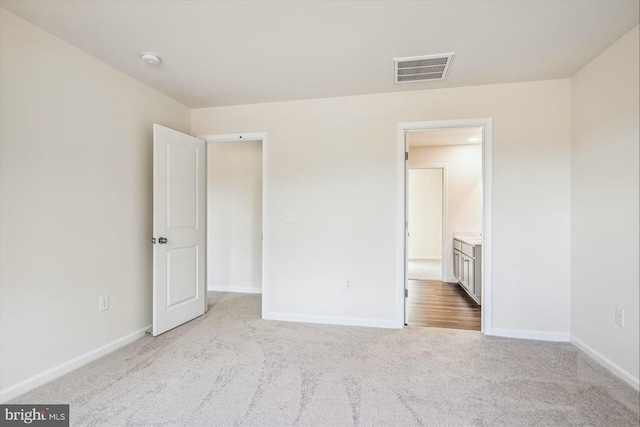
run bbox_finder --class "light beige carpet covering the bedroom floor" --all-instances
[11,293,640,426]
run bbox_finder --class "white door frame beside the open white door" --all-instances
[198,132,269,319]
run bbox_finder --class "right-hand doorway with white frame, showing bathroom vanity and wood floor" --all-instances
[398,119,491,334]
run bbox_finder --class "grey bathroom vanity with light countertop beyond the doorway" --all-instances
[453,234,482,305]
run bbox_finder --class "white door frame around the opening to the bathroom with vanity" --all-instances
[396,118,493,335]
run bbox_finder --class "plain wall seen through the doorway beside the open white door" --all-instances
[207,141,262,292]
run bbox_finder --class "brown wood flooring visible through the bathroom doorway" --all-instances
[407,280,480,331]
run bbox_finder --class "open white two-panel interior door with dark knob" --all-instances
[152,125,207,336]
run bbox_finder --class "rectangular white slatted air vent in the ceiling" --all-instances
[393,52,455,83]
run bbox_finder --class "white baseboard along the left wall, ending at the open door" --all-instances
[0,325,151,403]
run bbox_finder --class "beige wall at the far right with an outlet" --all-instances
[571,27,640,388]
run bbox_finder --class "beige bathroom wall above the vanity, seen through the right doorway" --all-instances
[409,144,482,282]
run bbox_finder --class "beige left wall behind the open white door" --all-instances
[0,9,189,396]
